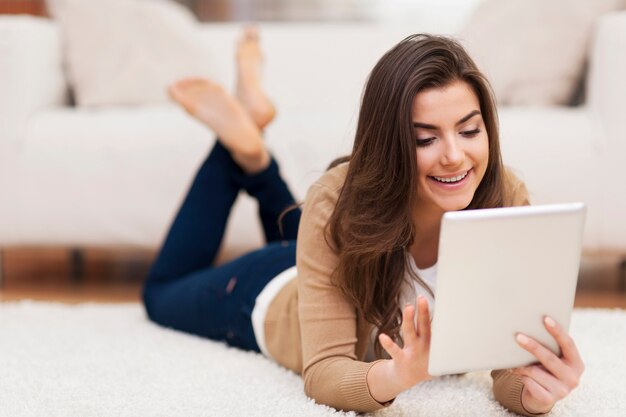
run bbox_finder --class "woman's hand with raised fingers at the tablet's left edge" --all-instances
[379,295,432,389]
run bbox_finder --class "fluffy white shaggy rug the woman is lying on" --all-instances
[0,301,626,417]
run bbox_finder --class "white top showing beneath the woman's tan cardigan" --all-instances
[252,255,437,361]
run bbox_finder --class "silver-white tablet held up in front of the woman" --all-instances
[428,203,585,376]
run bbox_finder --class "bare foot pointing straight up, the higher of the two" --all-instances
[237,26,276,129]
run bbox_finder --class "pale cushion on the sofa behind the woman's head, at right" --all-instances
[458,0,624,105]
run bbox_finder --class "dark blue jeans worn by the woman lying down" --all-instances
[143,142,300,352]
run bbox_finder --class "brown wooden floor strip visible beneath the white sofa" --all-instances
[0,248,626,309]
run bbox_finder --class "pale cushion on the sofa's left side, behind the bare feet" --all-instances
[48,0,211,106]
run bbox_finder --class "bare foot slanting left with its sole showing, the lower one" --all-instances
[167,78,270,174]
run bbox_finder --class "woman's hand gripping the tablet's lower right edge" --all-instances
[513,317,585,413]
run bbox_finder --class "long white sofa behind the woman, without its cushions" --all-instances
[0,12,626,272]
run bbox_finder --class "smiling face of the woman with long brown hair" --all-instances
[412,81,489,216]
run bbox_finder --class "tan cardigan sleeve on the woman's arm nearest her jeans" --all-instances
[296,182,393,412]
